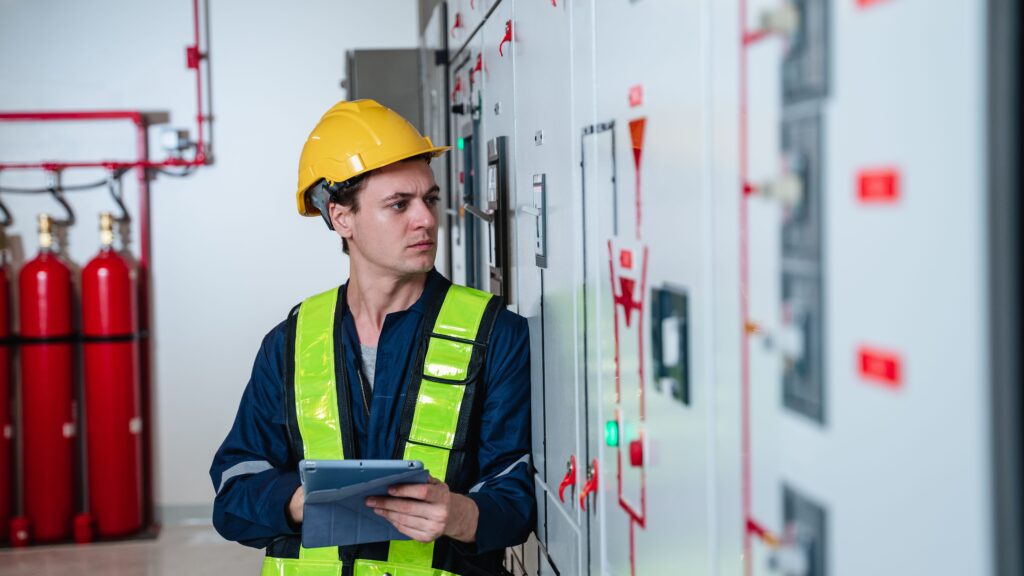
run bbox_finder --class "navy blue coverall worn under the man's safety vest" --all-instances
[210,271,536,553]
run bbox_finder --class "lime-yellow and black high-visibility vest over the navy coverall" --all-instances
[261,284,500,576]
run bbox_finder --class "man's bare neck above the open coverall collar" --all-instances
[346,262,429,346]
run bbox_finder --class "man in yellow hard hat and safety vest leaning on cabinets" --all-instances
[210,100,536,576]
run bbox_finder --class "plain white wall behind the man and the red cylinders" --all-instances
[0,0,417,517]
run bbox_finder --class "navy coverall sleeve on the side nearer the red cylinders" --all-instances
[210,324,300,548]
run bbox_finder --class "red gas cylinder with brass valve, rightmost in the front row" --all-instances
[82,212,142,537]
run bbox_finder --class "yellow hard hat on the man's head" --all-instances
[295,99,450,216]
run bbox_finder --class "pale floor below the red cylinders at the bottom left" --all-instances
[0,525,263,576]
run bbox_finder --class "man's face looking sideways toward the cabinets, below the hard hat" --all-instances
[331,160,440,277]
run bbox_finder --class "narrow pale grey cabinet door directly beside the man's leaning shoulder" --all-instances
[505,2,585,574]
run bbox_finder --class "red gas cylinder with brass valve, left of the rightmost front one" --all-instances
[18,214,75,542]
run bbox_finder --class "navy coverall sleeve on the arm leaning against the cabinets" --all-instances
[467,311,537,553]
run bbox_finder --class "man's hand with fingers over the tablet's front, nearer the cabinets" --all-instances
[367,477,480,542]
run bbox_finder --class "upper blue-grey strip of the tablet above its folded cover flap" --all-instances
[299,460,426,494]
